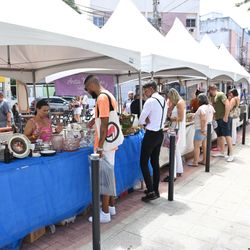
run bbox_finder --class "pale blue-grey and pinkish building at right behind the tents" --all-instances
[200,13,250,71]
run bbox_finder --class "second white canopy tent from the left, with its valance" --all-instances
[101,0,208,78]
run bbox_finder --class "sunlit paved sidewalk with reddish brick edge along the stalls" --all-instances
[23,129,250,250]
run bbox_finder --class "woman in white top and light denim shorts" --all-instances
[188,94,215,167]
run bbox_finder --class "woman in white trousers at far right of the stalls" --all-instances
[228,89,240,145]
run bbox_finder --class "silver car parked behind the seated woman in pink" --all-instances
[30,96,70,112]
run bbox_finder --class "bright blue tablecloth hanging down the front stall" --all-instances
[0,132,143,248]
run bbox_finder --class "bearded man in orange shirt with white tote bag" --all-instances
[84,75,118,223]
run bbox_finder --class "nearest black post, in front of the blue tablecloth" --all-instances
[90,154,101,250]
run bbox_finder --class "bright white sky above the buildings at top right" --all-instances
[200,0,250,28]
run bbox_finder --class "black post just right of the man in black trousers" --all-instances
[168,133,175,201]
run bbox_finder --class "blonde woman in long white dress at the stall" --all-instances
[164,88,186,181]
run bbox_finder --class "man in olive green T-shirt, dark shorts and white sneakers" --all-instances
[209,85,234,162]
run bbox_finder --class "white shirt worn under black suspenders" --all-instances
[139,93,167,131]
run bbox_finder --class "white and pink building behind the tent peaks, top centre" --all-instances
[76,0,200,39]
